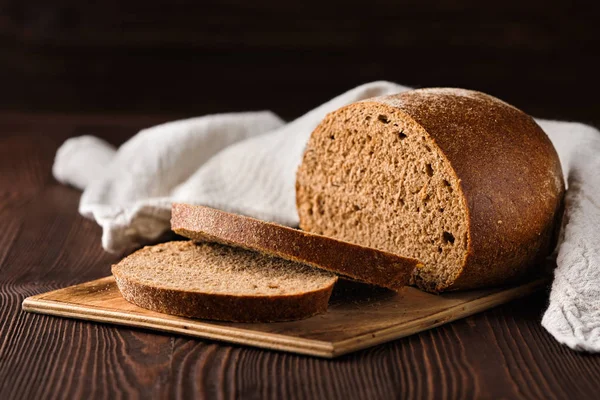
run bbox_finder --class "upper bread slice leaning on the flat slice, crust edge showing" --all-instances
[171,204,418,290]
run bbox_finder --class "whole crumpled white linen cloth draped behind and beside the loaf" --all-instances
[53,82,600,351]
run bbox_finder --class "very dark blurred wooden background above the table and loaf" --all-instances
[0,0,600,126]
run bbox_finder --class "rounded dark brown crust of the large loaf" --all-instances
[300,89,564,291]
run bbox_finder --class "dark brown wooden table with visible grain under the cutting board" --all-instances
[0,113,600,399]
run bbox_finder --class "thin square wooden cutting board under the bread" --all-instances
[23,276,548,358]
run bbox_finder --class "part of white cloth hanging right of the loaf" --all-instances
[541,122,600,352]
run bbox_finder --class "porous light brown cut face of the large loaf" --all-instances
[297,105,468,285]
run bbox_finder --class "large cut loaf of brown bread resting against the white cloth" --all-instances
[296,89,564,292]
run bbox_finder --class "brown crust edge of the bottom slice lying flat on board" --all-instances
[112,266,335,322]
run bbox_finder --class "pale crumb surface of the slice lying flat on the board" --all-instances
[114,241,336,296]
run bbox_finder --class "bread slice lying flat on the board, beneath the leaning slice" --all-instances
[112,241,337,322]
